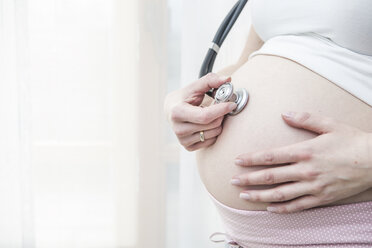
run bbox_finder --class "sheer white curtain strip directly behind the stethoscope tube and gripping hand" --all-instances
[177,0,250,248]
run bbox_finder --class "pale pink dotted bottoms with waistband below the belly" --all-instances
[210,194,372,248]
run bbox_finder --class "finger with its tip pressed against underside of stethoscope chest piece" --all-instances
[171,102,237,125]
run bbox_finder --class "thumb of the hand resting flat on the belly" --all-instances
[282,112,344,134]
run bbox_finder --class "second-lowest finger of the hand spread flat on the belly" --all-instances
[240,182,312,202]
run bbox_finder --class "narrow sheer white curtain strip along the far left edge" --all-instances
[0,1,34,247]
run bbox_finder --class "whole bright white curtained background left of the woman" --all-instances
[0,0,249,248]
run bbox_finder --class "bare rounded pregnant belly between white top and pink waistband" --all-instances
[196,55,372,210]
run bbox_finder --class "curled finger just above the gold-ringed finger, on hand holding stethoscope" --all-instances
[173,116,223,138]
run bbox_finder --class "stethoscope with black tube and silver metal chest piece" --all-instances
[199,0,249,115]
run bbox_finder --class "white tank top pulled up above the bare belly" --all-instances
[250,0,372,106]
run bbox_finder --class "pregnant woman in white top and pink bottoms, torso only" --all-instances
[165,0,372,248]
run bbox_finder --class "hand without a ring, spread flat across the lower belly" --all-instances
[231,112,372,213]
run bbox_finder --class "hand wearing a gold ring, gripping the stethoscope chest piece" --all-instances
[164,73,236,151]
